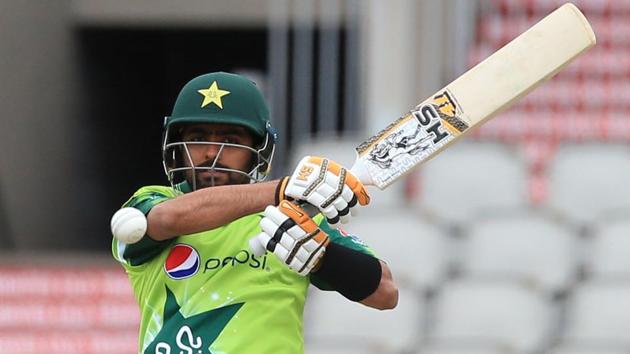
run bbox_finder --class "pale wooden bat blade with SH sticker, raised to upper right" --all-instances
[351,3,596,189]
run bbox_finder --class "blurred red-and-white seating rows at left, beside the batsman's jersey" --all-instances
[0,266,140,354]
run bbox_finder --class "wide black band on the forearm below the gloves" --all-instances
[313,242,383,301]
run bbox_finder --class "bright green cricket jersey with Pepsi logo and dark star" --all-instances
[112,186,373,354]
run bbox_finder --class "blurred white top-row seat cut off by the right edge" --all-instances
[548,143,630,225]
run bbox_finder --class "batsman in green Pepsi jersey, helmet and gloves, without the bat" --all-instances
[112,72,398,354]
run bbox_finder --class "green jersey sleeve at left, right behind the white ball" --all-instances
[112,186,177,266]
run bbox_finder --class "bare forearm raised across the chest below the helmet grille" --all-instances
[147,181,278,241]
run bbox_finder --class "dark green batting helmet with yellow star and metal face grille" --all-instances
[162,72,277,190]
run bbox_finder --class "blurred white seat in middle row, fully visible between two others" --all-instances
[457,212,578,293]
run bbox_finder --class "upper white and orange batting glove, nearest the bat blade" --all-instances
[279,156,370,227]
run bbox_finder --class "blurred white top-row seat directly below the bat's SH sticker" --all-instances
[414,142,528,223]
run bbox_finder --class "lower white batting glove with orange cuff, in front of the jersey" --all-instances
[249,200,330,276]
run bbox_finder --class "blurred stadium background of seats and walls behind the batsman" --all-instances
[0,0,630,354]
